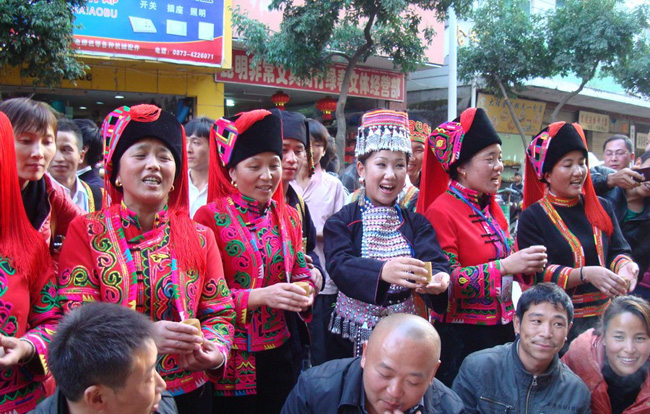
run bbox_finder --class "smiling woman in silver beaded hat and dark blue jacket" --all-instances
[323,110,449,357]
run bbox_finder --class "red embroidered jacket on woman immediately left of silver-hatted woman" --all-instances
[194,195,313,395]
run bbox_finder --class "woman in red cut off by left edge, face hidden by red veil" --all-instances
[0,112,61,414]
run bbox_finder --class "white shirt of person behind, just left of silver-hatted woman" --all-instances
[289,165,346,295]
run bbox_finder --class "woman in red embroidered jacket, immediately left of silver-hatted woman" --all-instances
[194,110,314,414]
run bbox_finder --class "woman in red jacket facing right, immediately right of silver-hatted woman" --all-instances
[417,108,546,386]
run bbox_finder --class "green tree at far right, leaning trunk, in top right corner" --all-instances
[546,0,647,121]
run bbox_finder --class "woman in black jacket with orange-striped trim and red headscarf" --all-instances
[517,122,639,349]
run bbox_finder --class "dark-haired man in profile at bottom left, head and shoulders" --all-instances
[32,302,177,414]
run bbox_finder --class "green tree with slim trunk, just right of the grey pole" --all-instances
[458,0,554,147]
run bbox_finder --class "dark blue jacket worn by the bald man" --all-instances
[281,357,463,414]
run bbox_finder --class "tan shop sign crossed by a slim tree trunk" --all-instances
[476,93,546,135]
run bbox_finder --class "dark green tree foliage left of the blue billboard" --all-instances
[0,0,87,87]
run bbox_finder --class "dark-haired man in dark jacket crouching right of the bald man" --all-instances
[453,283,591,414]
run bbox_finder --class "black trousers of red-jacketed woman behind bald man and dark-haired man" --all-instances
[434,322,515,387]
